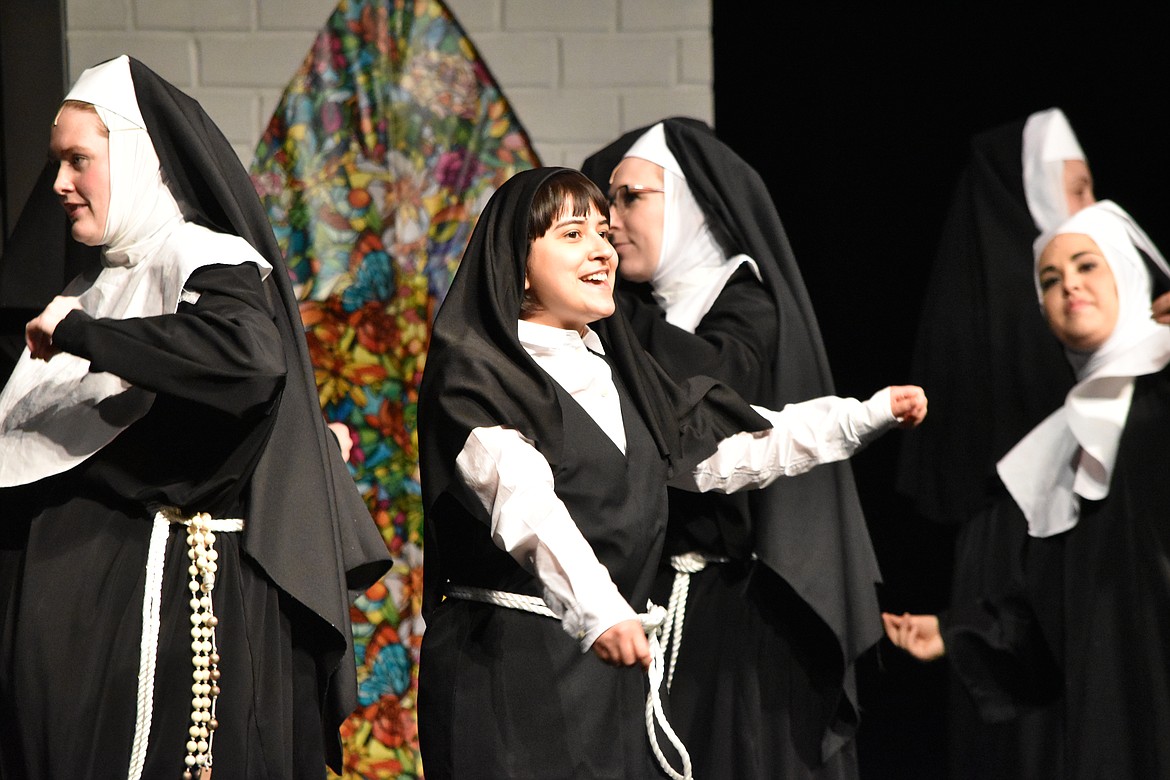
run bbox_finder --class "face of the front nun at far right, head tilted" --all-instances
[1037,233,1120,352]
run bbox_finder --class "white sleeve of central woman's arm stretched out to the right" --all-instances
[672,387,897,492]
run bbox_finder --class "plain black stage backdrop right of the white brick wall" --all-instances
[713,2,1170,779]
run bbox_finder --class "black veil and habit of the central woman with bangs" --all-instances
[419,168,768,780]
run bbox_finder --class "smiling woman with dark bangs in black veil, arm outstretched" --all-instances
[419,168,925,780]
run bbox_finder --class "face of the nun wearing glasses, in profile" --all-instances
[610,157,666,282]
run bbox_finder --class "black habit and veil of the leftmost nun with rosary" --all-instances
[0,58,390,778]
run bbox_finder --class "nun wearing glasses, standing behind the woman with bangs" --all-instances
[583,117,881,778]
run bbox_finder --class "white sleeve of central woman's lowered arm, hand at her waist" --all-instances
[455,426,638,653]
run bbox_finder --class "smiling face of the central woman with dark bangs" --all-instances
[521,198,618,332]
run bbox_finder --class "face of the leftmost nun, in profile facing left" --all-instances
[49,105,110,247]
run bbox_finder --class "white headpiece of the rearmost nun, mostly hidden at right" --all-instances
[1021,109,1085,233]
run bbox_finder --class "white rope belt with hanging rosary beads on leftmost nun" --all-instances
[128,509,243,780]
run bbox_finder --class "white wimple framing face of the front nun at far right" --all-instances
[997,201,1170,537]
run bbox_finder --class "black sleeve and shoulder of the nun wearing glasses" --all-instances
[621,265,779,402]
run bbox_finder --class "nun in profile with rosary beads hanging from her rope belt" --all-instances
[0,56,388,779]
